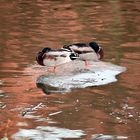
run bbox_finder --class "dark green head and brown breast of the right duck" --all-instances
[89,42,104,59]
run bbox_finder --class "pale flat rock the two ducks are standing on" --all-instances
[32,60,125,93]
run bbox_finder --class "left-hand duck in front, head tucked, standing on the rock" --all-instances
[36,47,79,72]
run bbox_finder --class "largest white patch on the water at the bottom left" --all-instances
[13,126,84,140]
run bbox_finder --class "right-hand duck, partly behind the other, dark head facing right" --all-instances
[62,42,104,65]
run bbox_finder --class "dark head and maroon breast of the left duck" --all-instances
[36,47,51,66]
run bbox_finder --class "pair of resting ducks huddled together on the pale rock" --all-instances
[36,42,103,69]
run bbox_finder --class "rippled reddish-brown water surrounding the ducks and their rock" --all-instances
[0,0,140,140]
